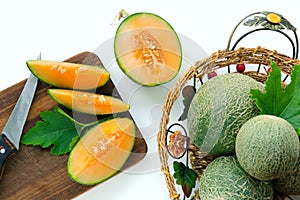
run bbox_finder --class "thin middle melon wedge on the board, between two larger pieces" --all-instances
[48,89,130,115]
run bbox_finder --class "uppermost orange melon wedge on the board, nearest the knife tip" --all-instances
[26,60,110,90]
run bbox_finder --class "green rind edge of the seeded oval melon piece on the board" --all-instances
[67,118,136,186]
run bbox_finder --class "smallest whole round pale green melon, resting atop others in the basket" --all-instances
[236,115,299,180]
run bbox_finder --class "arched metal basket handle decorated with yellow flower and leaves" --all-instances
[227,11,299,59]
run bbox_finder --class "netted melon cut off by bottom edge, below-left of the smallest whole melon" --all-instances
[199,156,274,200]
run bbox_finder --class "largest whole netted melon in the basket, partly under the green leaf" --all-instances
[187,73,264,155]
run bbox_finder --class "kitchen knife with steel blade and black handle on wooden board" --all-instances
[0,53,41,179]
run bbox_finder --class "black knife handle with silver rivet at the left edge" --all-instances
[0,134,17,179]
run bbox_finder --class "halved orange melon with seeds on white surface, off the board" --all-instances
[114,12,182,86]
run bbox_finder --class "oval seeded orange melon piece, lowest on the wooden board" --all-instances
[68,118,135,185]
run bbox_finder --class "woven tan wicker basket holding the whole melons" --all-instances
[157,12,300,200]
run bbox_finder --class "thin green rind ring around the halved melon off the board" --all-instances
[114,12,182,87]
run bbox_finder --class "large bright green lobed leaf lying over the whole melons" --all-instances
[251,62,300,135]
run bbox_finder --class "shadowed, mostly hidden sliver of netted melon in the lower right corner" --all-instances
[274,147,300,195]
